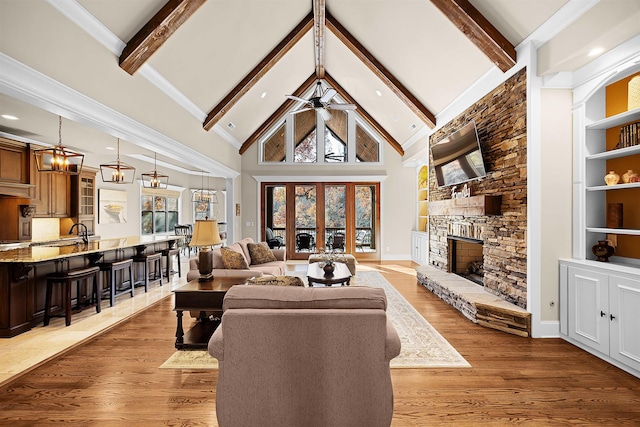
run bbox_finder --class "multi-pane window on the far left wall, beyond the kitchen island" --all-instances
[141,194,179,235]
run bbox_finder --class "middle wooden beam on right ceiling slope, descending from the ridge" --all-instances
[326,11,436,128]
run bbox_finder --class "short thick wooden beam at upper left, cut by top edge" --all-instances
[119,0,206,75]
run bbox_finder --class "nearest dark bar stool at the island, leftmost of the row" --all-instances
[44,266,101,326]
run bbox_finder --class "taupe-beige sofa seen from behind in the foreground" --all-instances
[208,285,400,427]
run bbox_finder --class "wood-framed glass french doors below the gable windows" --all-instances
[261,182,380,259]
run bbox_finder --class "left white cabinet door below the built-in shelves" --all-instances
[568,267,609,354]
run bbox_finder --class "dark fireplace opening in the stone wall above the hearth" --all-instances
[447,236,484,286]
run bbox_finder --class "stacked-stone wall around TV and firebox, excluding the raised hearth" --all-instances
[429,69,527,308]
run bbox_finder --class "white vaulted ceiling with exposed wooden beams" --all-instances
[0,0,640,176]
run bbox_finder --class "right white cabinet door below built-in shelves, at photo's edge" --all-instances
[609,275,640,371]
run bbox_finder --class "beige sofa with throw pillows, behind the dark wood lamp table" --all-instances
[187,237,286,280]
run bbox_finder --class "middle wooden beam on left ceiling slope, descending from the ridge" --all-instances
[202,12,313,130]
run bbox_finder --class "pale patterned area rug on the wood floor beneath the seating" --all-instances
[160,271,471,369]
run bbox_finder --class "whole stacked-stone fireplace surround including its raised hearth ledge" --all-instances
[417,69,530,336]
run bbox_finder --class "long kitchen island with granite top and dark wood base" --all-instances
[0,235,180,338]
